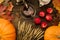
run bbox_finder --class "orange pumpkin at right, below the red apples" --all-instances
[44,26,60,40]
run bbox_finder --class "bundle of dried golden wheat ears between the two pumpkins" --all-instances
[17,20,44,40]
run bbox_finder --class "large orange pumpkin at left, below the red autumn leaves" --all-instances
[0,18,16,40]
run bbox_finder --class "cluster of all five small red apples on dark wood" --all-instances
[34,8,53,28]
